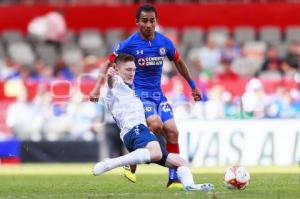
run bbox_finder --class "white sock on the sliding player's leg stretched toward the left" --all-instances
[107,149,150,169]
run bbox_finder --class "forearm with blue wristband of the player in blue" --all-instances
[174,58,202,101]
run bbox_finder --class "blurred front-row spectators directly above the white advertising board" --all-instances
[167,78,300,120]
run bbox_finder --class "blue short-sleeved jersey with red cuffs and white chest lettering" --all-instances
[113,32,179,98]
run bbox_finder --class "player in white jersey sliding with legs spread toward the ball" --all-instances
[93,53,214,191]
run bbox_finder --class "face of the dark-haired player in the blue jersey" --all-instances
[136,12,157,39]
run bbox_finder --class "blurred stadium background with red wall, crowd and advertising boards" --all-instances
[0,0,300,166]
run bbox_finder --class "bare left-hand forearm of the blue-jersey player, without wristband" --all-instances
[90,60,112,102]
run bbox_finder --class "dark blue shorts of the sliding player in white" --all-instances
[123,124,169,166]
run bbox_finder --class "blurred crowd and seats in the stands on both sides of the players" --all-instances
[0,10,300,141]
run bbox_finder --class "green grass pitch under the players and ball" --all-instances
[0,164,300,199]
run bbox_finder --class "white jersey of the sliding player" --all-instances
[103,75,147,140]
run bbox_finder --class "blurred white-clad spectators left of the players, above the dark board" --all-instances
[5,84,105,141]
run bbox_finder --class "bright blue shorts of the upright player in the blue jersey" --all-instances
[140,97,174,122]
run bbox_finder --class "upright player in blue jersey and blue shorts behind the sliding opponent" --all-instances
[90,4,201,188]
